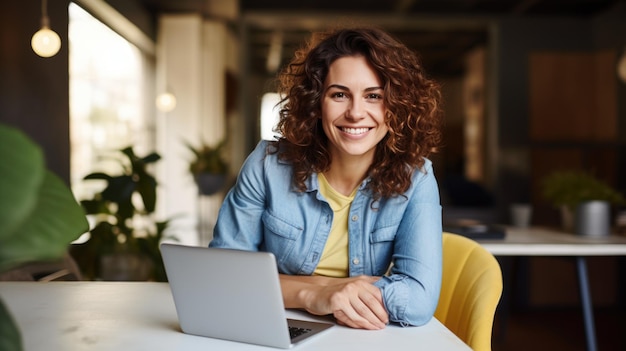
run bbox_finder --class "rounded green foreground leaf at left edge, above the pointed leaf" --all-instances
[0,125,45,245]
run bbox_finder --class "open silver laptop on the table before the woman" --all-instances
[161,243,334,349]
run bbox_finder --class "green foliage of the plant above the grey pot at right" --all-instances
[541,170,626,231]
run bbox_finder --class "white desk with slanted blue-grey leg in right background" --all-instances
[478,227,626,351]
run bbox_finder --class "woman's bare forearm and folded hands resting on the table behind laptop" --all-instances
[281,275,389,330]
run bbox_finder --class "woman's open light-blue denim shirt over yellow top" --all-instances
[209,141,442,326]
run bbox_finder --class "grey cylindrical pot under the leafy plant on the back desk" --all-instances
[574,201,611,236]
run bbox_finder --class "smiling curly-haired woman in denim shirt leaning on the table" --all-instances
[210,28,442,329]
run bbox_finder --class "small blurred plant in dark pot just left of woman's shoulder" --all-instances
[185,140,228,195]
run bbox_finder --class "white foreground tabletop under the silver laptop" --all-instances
[0,282,470,351]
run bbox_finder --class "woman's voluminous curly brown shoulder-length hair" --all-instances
[270,28,442,199]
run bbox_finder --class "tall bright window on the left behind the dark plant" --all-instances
[68,3,154,199]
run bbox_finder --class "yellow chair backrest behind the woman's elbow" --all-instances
[435,233,502,351]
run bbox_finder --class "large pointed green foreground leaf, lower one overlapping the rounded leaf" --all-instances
[0,171,89,271]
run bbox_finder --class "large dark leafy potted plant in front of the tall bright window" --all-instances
[72,147,174,281]
